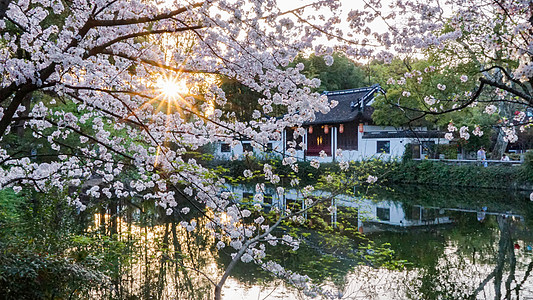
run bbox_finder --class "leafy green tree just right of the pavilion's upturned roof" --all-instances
[370,53,498,143]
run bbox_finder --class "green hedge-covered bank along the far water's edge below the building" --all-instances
[211,153,533,190]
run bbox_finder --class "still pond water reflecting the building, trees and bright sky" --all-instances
[101,186,533,299]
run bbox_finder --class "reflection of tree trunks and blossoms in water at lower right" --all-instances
[400,216,533,300]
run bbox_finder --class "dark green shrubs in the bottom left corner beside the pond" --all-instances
[0,190,133,299]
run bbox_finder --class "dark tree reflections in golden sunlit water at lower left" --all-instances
[109,211,214,299]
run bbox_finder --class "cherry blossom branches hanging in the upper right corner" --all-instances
[352,1,533,156]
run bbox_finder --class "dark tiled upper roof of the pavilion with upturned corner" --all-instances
[307,84,384,125]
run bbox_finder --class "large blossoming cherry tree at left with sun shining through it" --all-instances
[0,0,366,299]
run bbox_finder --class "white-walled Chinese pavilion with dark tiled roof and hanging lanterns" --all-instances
[215,85,448,161]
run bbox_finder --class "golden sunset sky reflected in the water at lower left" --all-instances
[89,214,221,299]
